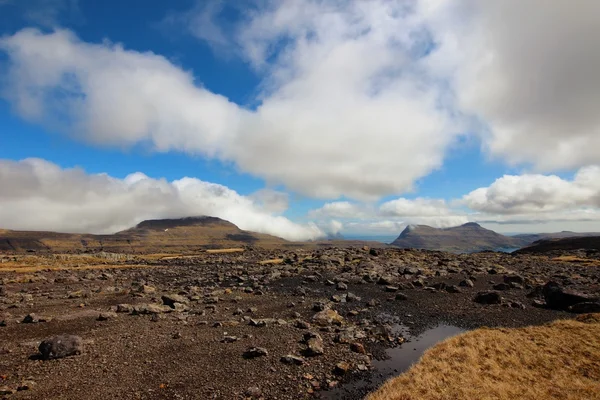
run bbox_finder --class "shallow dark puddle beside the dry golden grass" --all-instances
[321,325,466,400]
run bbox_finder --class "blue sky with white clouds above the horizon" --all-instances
[0,0,600,240]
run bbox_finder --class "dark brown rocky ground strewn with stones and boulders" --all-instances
[0,248,600,400]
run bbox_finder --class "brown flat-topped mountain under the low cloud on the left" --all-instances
[0,216,289,253]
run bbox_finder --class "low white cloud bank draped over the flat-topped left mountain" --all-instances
[0,159,324,240]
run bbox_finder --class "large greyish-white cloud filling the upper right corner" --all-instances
[422,0,600,171]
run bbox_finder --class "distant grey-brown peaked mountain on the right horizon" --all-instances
[392,222,528,253]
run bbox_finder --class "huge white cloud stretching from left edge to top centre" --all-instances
[0,0,459,200]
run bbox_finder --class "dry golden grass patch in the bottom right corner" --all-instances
[367,314,600,400]
